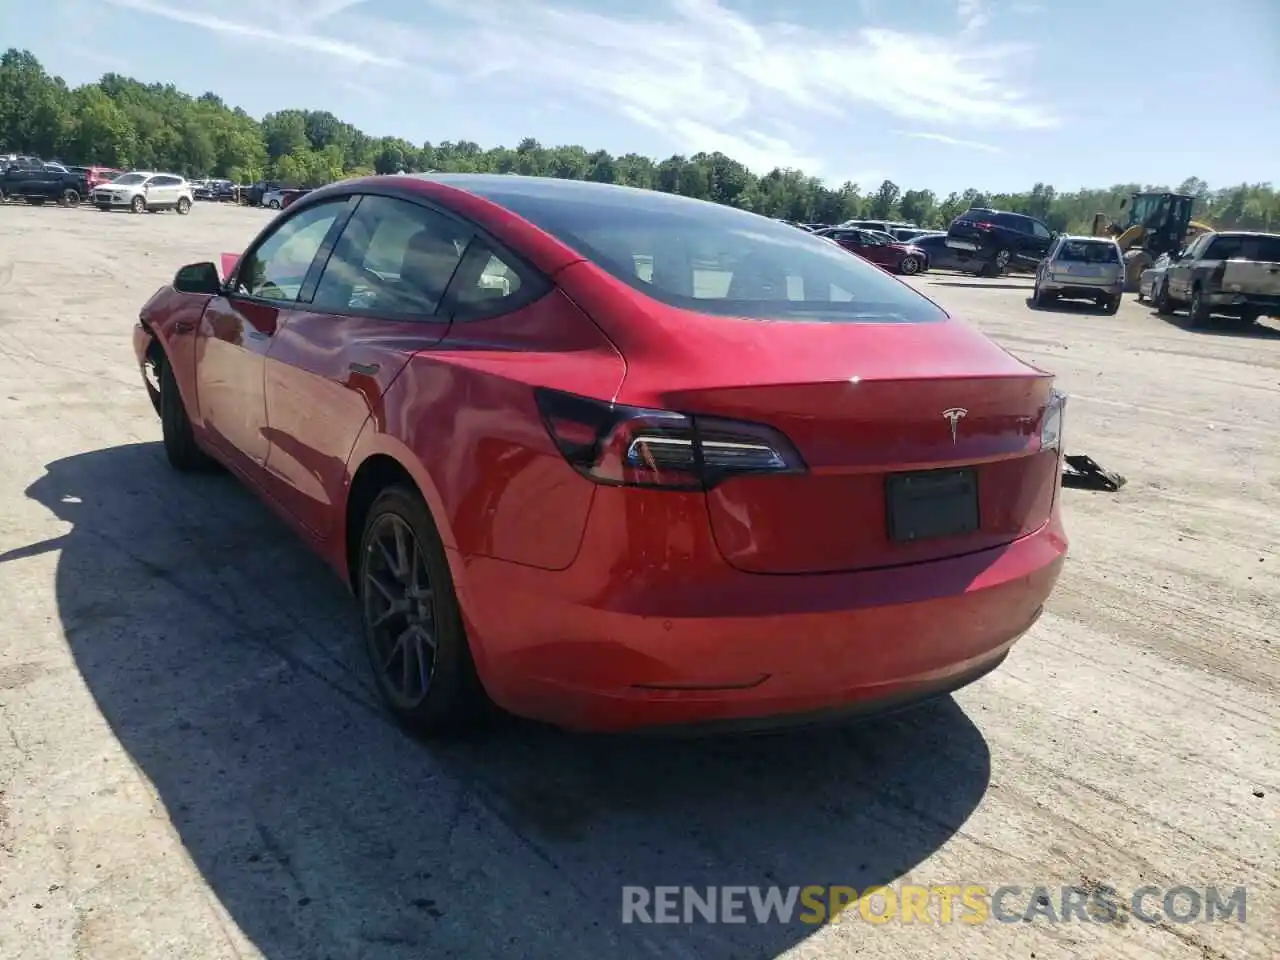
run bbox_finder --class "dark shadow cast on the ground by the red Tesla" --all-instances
[22,443,989,960]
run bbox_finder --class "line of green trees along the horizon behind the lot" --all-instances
[0,49,1280,232]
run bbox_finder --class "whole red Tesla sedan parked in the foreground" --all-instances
[134,174,1066,730]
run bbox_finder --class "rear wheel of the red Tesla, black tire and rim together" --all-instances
[355,485,486,735]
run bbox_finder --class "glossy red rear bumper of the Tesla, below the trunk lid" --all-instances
[452,488,1068,731]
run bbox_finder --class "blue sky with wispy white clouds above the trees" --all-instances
[0,0,1280,193]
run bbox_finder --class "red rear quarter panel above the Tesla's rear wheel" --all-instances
[348,289,626,570]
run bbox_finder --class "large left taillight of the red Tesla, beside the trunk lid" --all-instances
[535,388,805,490]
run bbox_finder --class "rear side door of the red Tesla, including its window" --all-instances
[266,193,474,541]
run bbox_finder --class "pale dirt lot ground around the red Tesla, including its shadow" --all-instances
[0,205,1280,960]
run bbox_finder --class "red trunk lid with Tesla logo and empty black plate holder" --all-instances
[650,320,1059,573]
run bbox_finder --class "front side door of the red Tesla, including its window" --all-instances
[196,197,349,474]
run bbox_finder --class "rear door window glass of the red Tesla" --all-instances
[312,196,471,317]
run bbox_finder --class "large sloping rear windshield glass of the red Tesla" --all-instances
[489,192,946,323]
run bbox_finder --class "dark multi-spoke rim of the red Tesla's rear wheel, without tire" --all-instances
[361,513,438,709]
